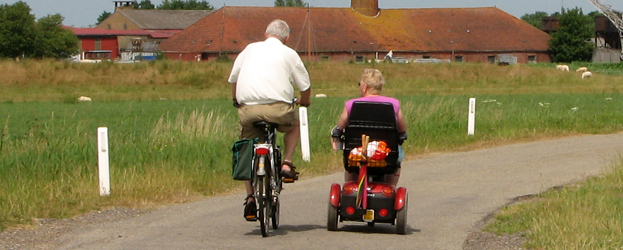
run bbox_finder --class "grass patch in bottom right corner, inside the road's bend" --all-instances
[486,162,623,249]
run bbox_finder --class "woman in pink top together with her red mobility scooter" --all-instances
[327,69,407,234]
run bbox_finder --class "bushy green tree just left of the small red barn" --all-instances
[33,14,79,59]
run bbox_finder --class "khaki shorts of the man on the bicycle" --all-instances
[238,102,299,140]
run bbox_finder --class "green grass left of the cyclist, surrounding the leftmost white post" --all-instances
[0,100,241,224]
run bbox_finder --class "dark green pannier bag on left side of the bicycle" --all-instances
[231,139,255,181]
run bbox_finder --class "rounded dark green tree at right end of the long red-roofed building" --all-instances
[549,7,594,62]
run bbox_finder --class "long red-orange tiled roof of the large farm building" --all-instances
[160,7,550,52]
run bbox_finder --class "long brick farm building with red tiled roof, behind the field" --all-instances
[159,0,550,63]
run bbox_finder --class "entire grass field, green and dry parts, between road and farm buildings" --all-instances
[0,60,623,249]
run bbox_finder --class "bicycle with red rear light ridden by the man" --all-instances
[251,121,283,237]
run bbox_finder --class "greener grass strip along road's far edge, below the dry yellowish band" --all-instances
[0,94,623,232]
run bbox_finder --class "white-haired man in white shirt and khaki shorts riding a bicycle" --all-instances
[228,19,311,221]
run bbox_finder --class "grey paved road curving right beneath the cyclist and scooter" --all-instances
[55,134,623,250]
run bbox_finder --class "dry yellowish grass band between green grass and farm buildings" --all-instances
[0,60,623,102]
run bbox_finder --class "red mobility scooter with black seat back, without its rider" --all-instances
[327,102,407,234]
